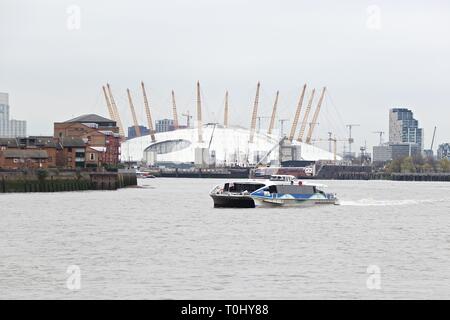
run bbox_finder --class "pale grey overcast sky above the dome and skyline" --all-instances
[0,0,450,148]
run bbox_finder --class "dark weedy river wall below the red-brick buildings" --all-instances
[0,171,137,193]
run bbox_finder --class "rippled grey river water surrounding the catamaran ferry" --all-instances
[0,178,450,299]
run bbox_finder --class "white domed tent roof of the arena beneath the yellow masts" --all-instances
[121,124,334,166]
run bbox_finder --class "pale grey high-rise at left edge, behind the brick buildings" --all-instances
[0,92,27,138]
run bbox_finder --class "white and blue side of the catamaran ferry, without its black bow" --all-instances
[250,179,338,207]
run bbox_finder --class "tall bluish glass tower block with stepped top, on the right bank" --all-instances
[389,108,423,150]
